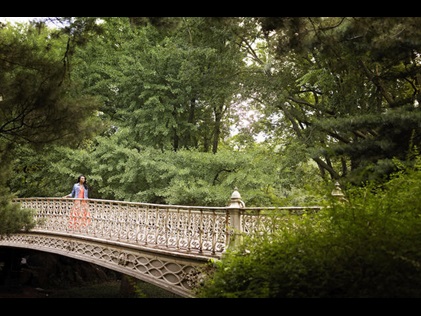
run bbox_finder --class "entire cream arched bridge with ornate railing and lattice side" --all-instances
[0,191,320,297]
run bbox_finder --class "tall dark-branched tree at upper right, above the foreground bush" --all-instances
[241,17,421,184]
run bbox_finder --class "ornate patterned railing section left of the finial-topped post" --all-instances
[15,198,230,257]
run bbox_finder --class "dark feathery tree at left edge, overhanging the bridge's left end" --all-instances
[0,18,104,234]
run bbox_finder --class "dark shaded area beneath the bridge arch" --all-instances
[0,247,180,298]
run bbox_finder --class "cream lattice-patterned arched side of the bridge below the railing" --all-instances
[0,232,210,297]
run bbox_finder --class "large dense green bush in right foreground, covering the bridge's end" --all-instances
[198,154,421,298]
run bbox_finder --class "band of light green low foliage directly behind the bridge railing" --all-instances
[9,138,320,206]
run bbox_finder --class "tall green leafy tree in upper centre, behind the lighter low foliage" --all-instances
[70,18,242,152]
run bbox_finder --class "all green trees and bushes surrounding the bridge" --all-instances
[0,17,421,297]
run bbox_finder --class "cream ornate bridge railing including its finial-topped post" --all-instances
[14,191,320,258]
